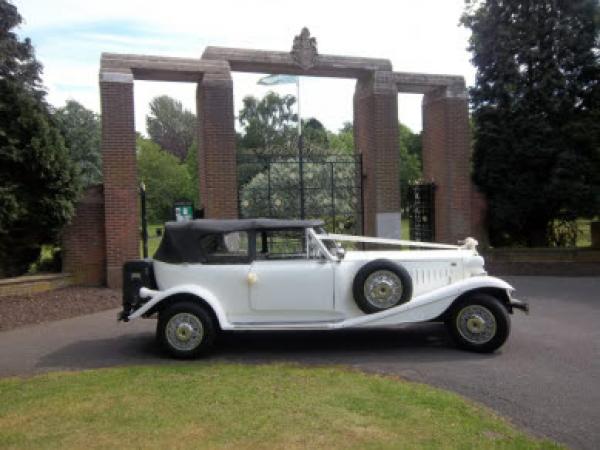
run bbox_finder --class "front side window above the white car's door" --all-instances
[256,229,307,260]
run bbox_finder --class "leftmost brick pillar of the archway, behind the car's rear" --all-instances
[100,72,140,288]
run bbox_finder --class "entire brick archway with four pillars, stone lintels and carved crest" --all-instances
[92,30,475,287]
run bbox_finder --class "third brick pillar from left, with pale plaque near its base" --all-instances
[354,71,401,239]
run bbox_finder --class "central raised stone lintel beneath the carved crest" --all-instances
[202,46,392,78]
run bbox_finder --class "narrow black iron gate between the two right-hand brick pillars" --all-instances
[408,183,435,242]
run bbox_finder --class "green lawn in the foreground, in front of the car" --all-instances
[0,363,560,450]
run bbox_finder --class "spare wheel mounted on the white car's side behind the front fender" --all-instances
[352,259,412,313]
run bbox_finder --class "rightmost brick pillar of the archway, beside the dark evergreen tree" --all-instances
[423,84,477,244]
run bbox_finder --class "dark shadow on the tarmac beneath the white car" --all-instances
[36,324,494,370]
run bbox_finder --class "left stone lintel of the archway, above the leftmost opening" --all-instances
[100,53,229,83]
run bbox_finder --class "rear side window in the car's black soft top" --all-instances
[200,231,248,264]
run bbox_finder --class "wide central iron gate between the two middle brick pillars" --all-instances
[237,154,363,235]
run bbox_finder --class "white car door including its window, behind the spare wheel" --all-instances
[249,229,334,312]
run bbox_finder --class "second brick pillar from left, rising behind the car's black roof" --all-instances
[196,72,238,219]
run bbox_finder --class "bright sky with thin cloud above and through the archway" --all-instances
[13,0,475,134]
